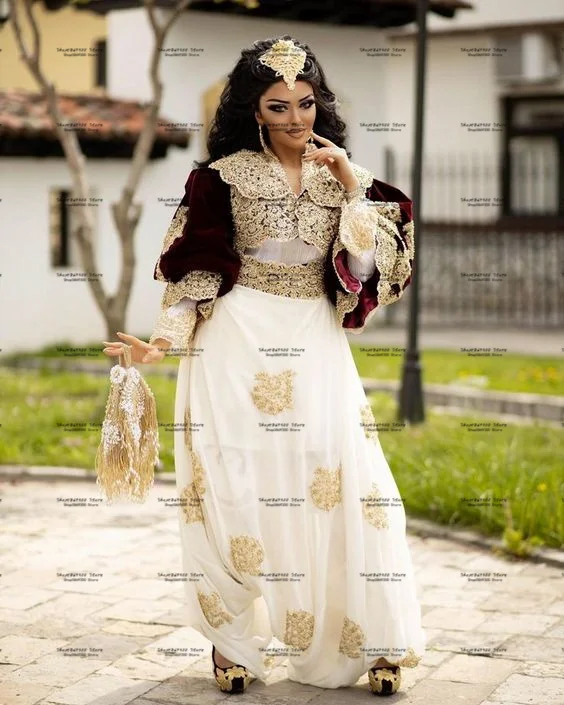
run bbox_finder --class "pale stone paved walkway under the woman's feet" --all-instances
[0,480,564,705]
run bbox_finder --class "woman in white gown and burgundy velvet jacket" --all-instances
[104,36,425,695]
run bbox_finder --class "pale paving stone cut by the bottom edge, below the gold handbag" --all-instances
[38,673,154,705]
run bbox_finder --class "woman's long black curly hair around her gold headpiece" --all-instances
[194,34,351,167]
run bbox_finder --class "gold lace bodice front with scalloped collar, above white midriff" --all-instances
[210,149,373,258]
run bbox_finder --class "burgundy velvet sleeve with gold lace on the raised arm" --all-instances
[330,179,415,333]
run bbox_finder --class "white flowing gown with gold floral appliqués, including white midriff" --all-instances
[148,150,425,688]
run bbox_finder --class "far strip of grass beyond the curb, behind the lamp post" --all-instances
[351,345,564,396]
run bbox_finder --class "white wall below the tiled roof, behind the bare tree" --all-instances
[0,158,173,352]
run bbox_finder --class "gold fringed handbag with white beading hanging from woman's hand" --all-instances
[96,345,159,502]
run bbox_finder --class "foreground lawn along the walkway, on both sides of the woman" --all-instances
[0,369,564,551]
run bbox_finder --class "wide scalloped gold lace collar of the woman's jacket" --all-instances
[209,149,374,207]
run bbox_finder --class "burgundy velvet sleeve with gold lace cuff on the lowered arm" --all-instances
[149,167,241,356]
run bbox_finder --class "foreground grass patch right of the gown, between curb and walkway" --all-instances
[371,393,564,547]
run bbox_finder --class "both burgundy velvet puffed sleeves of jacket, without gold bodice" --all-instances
[154,157,414,332]
